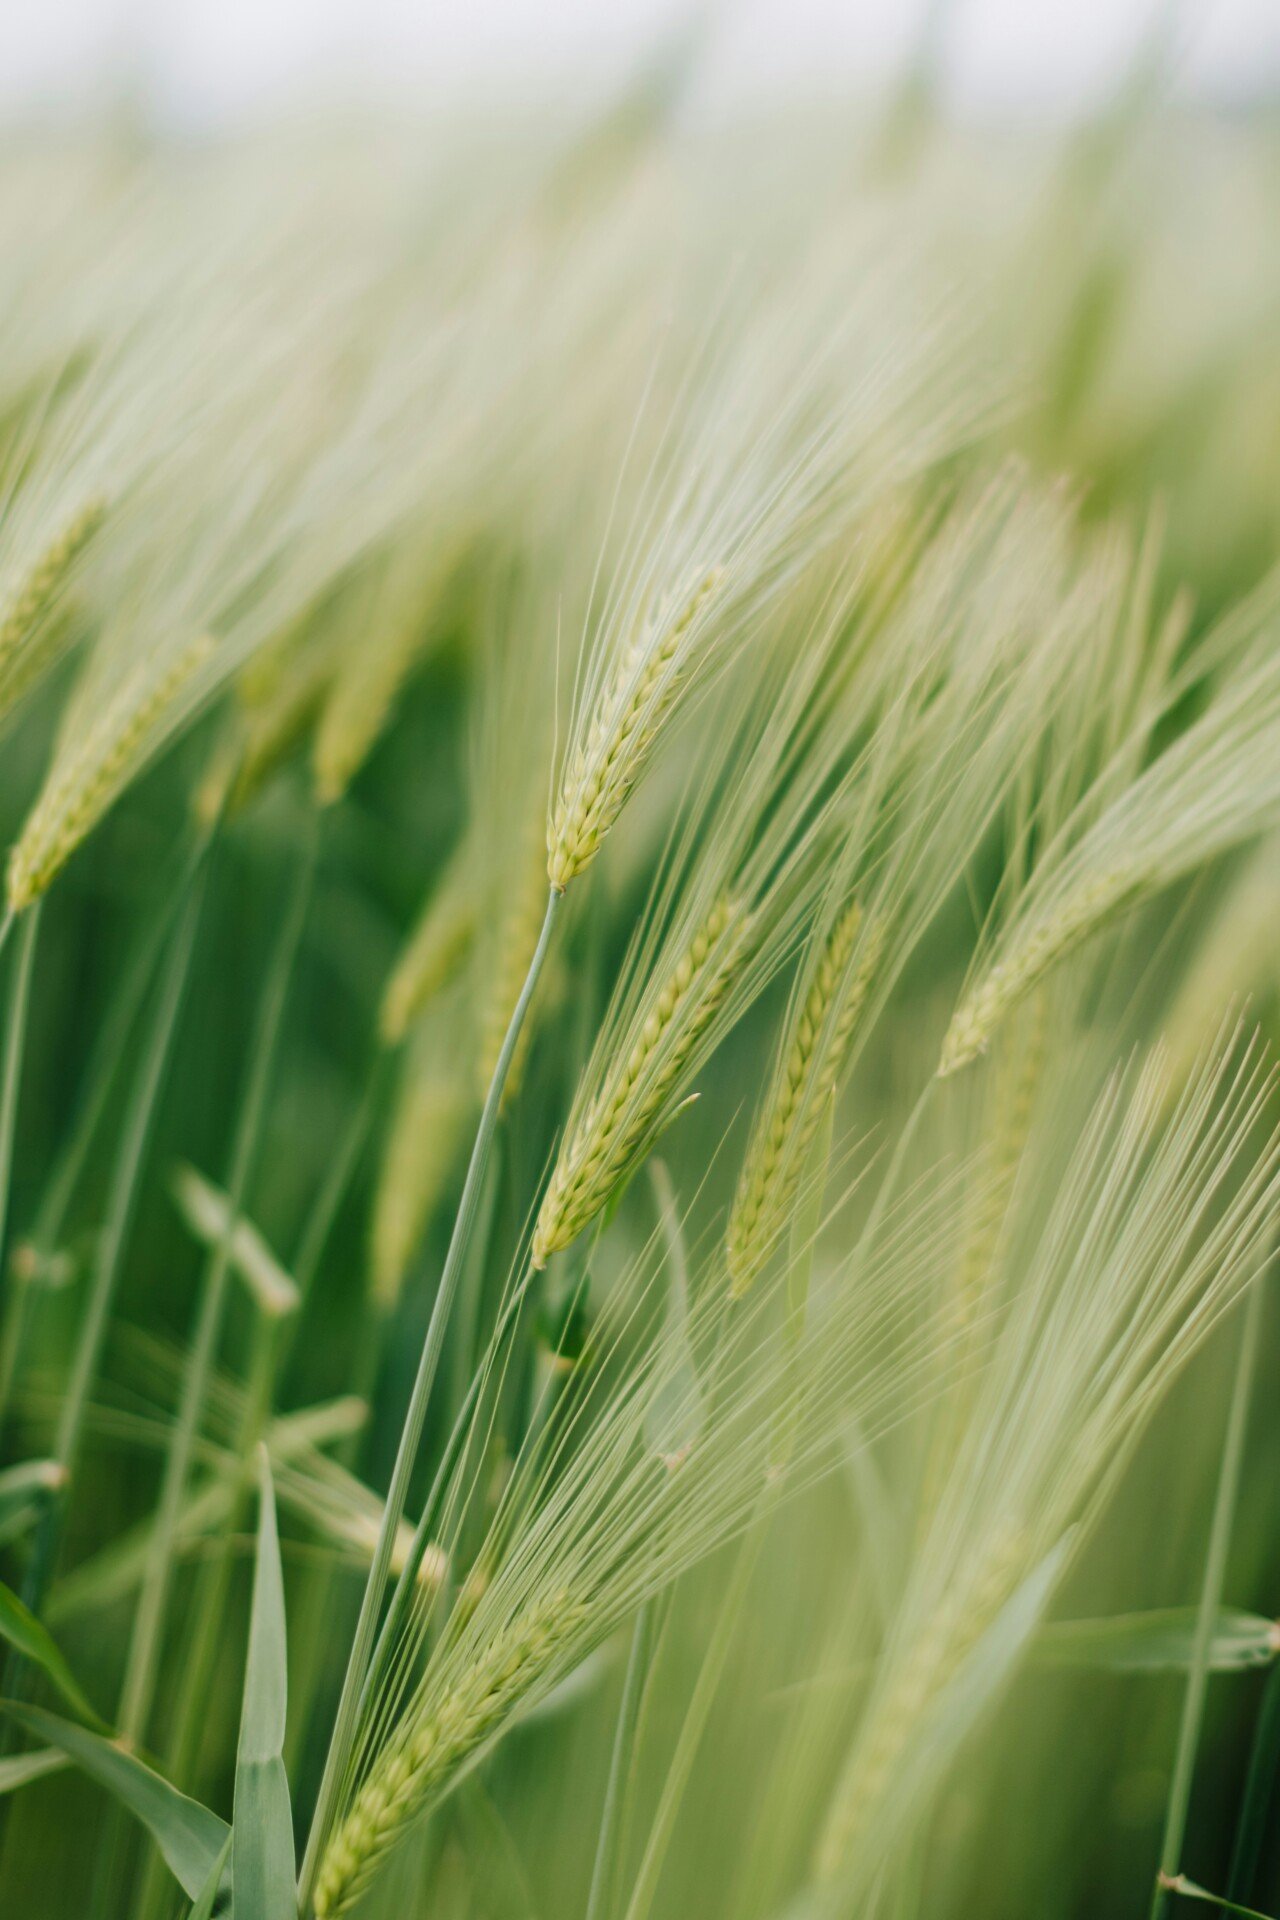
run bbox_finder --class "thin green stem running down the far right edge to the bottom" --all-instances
[1151,1277,1263,1920]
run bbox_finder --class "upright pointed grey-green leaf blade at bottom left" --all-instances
[230,1448,297,1920]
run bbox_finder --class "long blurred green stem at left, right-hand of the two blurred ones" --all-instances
[119,835,319,1741]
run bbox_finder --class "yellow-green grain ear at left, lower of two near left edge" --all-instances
[8,634,217,912]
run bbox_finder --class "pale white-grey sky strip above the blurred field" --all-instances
[0,0,1280,125]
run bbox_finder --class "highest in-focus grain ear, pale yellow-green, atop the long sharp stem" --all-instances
[547,566,723,893]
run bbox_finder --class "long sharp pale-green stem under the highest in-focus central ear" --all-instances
[299,887,560,1910]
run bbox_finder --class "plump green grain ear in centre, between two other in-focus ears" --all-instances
[532,897,750,1267]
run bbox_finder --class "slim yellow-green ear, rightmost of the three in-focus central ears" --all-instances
[725,900,883,1298]
